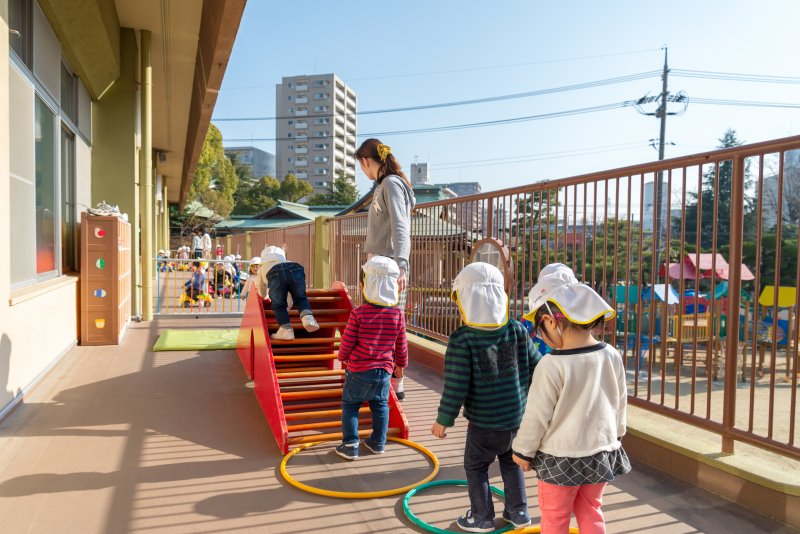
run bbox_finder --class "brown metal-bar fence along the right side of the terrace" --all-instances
[330,137,800,457]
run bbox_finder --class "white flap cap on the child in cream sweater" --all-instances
[524,263,616,324]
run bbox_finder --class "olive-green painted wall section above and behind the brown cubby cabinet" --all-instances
[92,28,141,315]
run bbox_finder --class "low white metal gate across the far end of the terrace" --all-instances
[154,258,255,315]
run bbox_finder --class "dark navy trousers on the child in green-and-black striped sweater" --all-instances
[464,423,528,522]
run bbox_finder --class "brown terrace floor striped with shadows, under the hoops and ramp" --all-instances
[0,316,796,534]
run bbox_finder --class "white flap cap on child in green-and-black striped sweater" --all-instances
[453,262,508,328]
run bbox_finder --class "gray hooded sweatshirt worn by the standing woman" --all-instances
[364,174,417,271]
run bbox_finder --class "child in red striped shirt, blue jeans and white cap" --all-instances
[336,256,408,460]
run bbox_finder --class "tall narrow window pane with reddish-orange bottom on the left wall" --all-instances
[34,96,57,275]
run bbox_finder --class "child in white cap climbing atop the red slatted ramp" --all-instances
[258,246,319,340]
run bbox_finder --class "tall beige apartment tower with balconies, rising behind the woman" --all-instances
[275,74,357,193]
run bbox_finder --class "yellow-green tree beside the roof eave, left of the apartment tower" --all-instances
[187,124,239,218]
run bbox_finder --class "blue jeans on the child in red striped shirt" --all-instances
[342,369,391,449]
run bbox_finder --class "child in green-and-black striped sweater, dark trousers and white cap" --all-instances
[431,262,539,532]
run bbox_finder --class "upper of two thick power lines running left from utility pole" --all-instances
[212,71,660,122]
